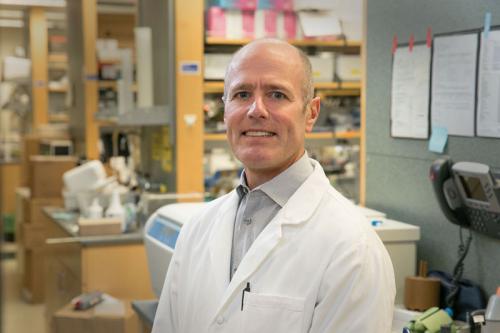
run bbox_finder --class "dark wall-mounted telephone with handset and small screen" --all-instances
[430,158,500,238]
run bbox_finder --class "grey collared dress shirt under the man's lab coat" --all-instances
[230,152,313,279]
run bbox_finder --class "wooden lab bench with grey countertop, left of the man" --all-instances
[43,207,154,332]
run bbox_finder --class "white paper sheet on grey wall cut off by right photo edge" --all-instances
[476,30,500,138]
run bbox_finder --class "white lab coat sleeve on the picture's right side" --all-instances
[309,234,396,333]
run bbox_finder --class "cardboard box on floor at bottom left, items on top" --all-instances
[53,301,140,333]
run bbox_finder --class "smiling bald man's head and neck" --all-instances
[224,39,320,188]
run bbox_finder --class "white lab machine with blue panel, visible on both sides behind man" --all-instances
[144,203,420,330]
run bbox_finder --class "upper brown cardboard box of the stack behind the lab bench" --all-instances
[29,155,77,198]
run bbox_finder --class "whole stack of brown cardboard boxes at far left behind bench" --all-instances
[16,135,77,303]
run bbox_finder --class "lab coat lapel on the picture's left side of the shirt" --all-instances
[209,191,238,299]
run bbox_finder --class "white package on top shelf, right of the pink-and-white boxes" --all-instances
[299,11,342,37]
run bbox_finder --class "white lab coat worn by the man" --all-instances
[153,160,396,333]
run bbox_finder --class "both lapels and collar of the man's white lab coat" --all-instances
[210,160,330,321]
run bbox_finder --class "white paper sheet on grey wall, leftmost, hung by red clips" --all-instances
[391,45,431,139]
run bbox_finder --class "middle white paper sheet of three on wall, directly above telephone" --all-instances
[431,33,478,136]
